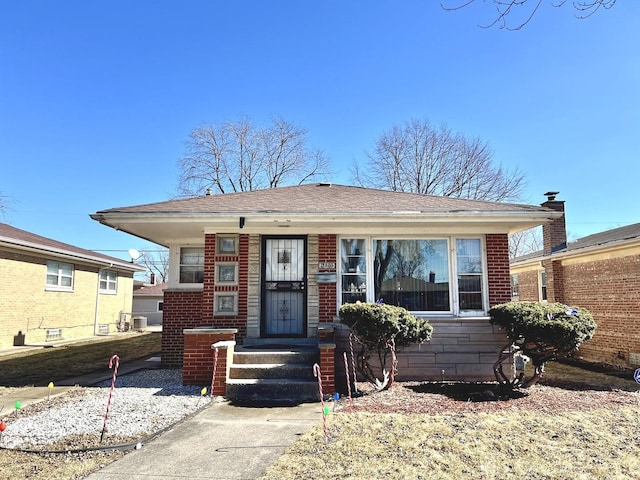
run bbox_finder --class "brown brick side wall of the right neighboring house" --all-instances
[563,255,640,365]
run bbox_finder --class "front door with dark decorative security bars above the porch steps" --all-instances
[262,237,307,337]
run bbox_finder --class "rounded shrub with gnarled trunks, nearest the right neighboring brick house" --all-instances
[489,302,596,386]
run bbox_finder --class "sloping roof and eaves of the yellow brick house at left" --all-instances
[0,223,144,272]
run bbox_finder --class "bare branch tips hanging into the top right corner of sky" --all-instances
[440,0,616,30]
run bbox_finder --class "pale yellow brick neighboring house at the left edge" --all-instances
[0,223,143,348]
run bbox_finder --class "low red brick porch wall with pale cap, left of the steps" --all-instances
[182,328,238,395]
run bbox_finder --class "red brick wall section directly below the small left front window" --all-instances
[161,290,203,367]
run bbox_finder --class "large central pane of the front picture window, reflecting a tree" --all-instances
[373,239,451,312]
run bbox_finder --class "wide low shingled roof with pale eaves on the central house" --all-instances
[91,183,560,246]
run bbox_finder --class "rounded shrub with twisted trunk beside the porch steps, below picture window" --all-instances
[339,302,433,389]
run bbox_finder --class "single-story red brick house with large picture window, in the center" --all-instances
[92,183,559,398]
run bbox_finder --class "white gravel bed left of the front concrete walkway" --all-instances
[0,369,211,449]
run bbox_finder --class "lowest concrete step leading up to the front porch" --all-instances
[227,379,320,405]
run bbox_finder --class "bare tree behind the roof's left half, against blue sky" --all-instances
[178,118,330,196]
